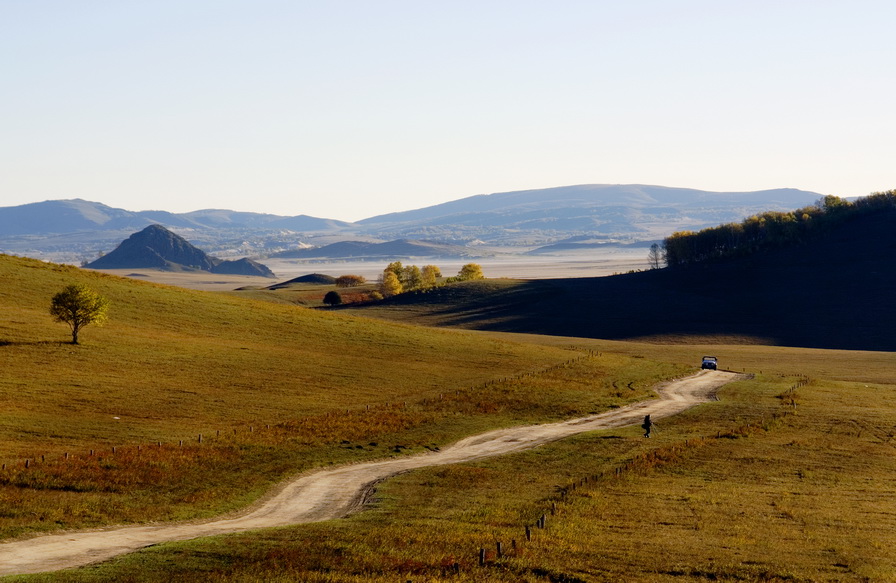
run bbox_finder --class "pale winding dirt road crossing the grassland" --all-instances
[0,371,738,575]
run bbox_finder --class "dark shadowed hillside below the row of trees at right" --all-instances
[344,205,896,351]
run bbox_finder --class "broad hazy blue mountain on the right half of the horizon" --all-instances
[359,184,821,241]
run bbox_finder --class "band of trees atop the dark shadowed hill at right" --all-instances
[649,190,896,267]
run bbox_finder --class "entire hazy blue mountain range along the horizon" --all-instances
[0,184,822,262]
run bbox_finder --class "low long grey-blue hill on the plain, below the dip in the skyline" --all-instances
[273,239,470,259]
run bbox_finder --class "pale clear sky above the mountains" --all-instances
[0,0,896,221]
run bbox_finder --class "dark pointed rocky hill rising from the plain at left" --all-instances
[86,224,274,277]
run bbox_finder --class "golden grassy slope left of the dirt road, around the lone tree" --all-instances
[0,256,683,536]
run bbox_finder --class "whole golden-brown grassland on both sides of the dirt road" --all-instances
[0,258,896,583]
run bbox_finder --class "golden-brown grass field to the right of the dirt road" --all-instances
[8,344,896,583]
